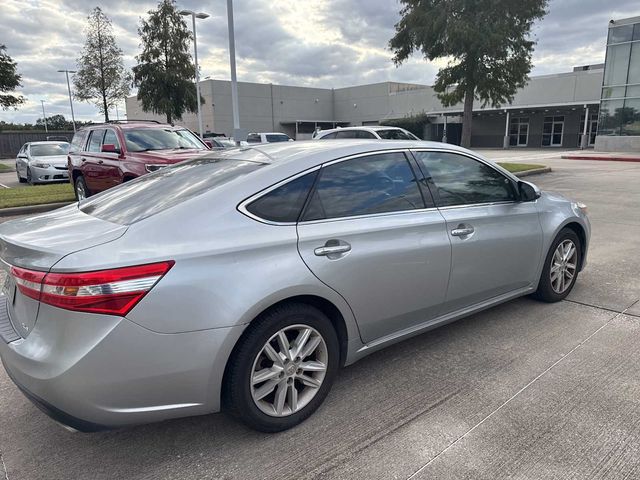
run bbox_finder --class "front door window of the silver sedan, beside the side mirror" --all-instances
[414,152,516,207]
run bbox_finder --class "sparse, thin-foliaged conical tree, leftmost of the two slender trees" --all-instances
[73,7,131,122]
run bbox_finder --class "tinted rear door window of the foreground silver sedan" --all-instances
[302,152,425,221]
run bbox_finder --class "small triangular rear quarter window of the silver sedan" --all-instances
[247,171,318,223]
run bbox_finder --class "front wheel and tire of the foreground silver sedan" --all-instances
[533,228,582,303]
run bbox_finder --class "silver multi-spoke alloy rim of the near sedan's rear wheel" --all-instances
[250,325,329,417]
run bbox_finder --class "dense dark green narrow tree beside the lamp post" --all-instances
[133,0,198,123]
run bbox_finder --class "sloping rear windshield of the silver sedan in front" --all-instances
[80,158,265,225]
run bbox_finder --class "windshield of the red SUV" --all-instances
[124,128,205,152]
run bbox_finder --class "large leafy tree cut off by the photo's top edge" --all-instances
[389,0,548,147]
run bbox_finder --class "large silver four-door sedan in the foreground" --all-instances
[0,140,590,432]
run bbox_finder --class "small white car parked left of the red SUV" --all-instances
[16,142,69,185]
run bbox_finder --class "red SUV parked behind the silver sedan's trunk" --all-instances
[68,120,209,200]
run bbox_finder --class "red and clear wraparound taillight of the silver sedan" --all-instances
[11,260,174,315]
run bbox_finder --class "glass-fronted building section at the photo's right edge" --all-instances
[598,17,640,136]
